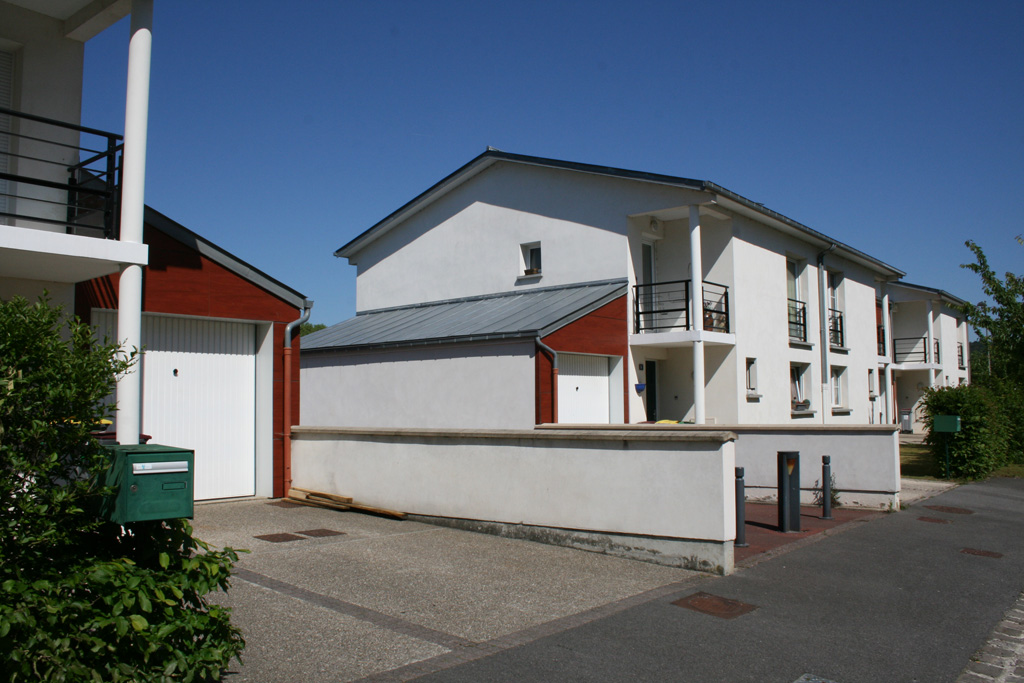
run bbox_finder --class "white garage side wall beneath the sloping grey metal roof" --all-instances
[300,342,537,429]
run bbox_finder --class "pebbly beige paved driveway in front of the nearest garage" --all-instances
[194,501,708,682]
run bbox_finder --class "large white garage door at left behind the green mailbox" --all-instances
[92,310,256,501]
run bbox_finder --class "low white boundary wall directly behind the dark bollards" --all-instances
[539,425,900,510]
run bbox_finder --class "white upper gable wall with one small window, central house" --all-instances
[353,162,708,311]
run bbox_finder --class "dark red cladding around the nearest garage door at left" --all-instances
[75,224,300,497]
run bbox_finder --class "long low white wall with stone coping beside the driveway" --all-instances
[292,426,736,573]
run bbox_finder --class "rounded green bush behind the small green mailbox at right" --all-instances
[924,384,1010,479]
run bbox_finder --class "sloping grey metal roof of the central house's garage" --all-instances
[302,279,626,353]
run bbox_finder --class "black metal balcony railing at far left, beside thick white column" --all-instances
[0,108,122,240]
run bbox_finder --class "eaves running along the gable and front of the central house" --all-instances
[334,147,905,279]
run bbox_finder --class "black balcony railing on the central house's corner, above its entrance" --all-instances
[633,280,729,334]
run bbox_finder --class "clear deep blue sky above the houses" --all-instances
[82,0,1024,324]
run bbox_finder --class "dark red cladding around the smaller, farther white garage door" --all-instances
[534,296,630,424]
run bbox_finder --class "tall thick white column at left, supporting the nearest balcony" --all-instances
[117,0,153,445]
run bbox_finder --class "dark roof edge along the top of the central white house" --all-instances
[334,147,906,278]
